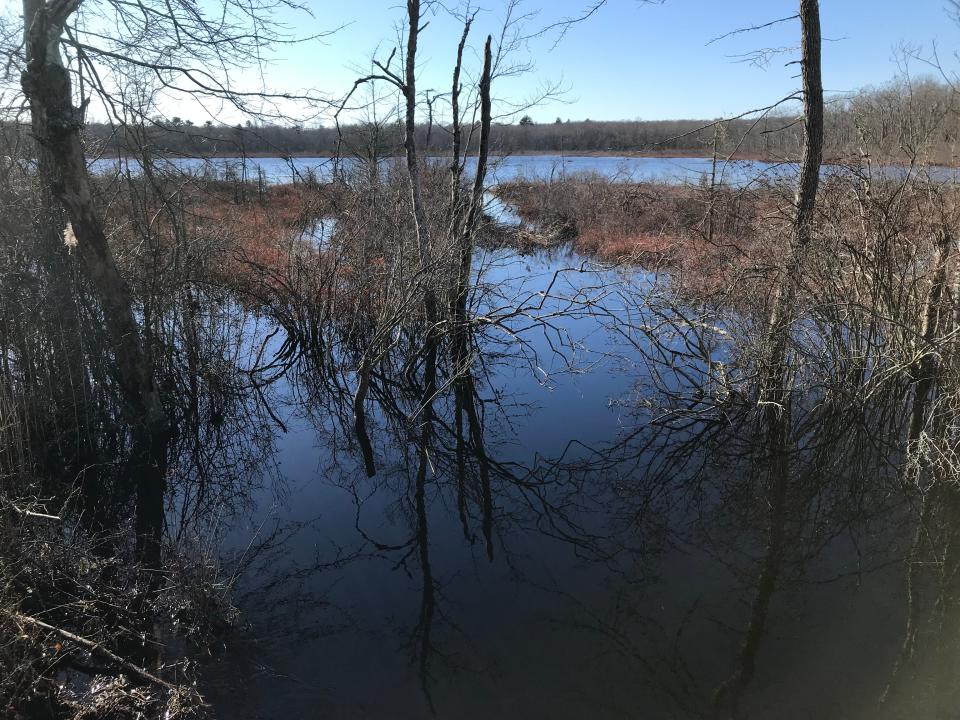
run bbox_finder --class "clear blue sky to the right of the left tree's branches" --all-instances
[248,0,960,121]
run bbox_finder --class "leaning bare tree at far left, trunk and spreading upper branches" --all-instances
[15,0,308,560]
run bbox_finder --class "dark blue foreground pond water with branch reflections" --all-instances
[124,238,957,718]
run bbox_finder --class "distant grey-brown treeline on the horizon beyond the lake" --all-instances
[7,80,960,163]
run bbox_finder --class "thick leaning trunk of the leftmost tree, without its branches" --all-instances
[21,0,169,564]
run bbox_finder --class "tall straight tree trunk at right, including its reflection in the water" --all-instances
[714,0,823,716]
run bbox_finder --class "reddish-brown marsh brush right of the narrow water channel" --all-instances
[496,174,960,304]
